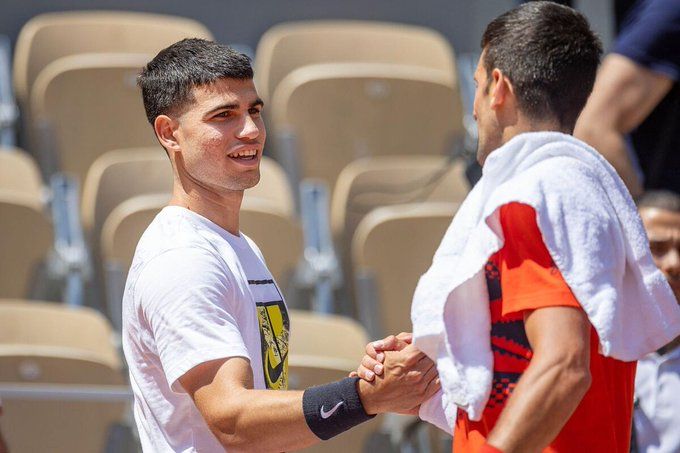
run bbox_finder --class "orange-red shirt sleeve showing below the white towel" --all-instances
[500,203,581,316]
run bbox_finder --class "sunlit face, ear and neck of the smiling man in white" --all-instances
[154,79,267,235]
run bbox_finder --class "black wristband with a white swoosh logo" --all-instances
[302,378,375,440]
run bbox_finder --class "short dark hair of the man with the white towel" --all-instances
[482,1,602,131]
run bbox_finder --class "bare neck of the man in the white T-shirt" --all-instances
[170,178,243,236]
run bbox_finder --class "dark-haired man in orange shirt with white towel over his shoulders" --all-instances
[358,2,680,453]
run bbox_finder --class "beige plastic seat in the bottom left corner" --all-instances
[0,302,126,453]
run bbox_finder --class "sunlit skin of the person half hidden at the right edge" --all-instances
[640,208,680,353]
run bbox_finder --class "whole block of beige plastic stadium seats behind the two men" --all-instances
[0,12,469,451]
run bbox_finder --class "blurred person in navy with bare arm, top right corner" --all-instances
[574,0,680,197]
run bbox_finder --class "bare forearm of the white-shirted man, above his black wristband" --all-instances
[211,389,319,452]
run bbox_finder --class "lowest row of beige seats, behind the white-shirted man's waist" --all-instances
[0,299,394,453]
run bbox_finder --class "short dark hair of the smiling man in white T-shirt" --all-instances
[137,38,253,125]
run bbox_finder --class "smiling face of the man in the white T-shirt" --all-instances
[174,79,267,195]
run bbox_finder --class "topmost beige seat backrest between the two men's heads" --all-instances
[255,21,456,101]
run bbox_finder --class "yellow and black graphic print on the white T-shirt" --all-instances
[257,301,290,390]
